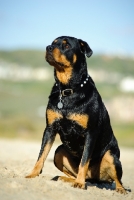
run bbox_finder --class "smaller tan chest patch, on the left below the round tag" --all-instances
[47,109,63,125]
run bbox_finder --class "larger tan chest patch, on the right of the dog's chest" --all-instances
[67,113,89,128]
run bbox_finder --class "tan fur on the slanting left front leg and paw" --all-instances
[26,142,53,178]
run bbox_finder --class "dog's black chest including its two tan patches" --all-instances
[47,109,88,156]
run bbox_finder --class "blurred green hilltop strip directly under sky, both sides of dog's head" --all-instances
[0,50,134,75]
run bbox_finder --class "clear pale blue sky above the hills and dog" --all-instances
[0,0,134,55]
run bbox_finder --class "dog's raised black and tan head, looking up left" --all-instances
[46,36,93,84]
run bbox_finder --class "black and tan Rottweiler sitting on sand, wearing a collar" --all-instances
[26,36,126,193]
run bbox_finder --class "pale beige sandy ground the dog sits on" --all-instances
[0,140,134,200]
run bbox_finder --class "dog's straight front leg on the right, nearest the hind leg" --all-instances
[72,133,94,189]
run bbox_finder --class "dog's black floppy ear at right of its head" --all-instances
[78,39,93,57]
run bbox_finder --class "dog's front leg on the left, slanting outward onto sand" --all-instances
[26,127,56,178]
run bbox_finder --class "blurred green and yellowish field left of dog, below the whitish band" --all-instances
[0,80,52,139]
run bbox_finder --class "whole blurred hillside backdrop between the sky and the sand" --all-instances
[0,50,134,147]
